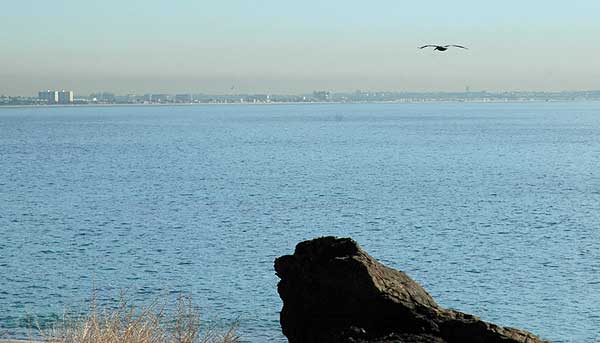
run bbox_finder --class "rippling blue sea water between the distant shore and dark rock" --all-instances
[0,102,600,343]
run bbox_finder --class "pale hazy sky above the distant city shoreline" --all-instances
[0,0,600,95]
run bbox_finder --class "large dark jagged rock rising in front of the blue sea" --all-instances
[275,237,544,343]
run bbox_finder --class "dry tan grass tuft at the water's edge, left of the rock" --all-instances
[40,296,239,343]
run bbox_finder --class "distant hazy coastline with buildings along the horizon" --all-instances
[0,90,600,107]
